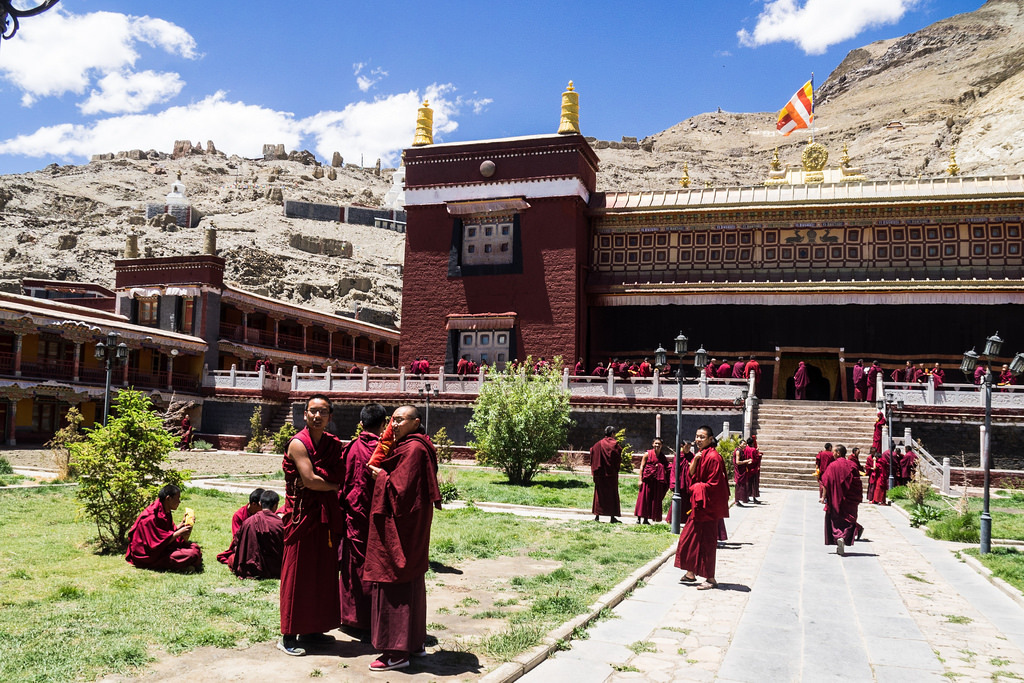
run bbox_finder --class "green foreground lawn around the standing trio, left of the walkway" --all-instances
[0,488,673,681]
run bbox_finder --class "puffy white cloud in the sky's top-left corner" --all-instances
[0,6,198,105]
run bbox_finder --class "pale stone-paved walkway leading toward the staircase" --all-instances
[521,490,1024,683]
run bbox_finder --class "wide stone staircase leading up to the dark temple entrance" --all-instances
[756,400,878,488]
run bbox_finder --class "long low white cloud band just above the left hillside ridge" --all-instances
[0,83,481,165]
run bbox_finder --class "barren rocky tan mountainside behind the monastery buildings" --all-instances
[0,0,1024,322]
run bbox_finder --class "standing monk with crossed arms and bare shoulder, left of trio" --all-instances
[278,394,343,656]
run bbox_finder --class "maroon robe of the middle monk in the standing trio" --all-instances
[338,431,380,630]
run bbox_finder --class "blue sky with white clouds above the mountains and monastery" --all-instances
[0,0,983,173]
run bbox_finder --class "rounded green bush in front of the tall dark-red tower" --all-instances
[466,357,572,484]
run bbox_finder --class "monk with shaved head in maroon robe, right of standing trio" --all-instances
[362,405,441,671]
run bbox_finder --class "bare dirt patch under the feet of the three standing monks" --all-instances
[101,556,559,683]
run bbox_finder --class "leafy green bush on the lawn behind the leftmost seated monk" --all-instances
[69,389,191,552]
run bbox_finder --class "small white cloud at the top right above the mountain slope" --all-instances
[736,0,921,54]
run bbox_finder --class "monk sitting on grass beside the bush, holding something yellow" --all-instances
[125,484,203,571]
